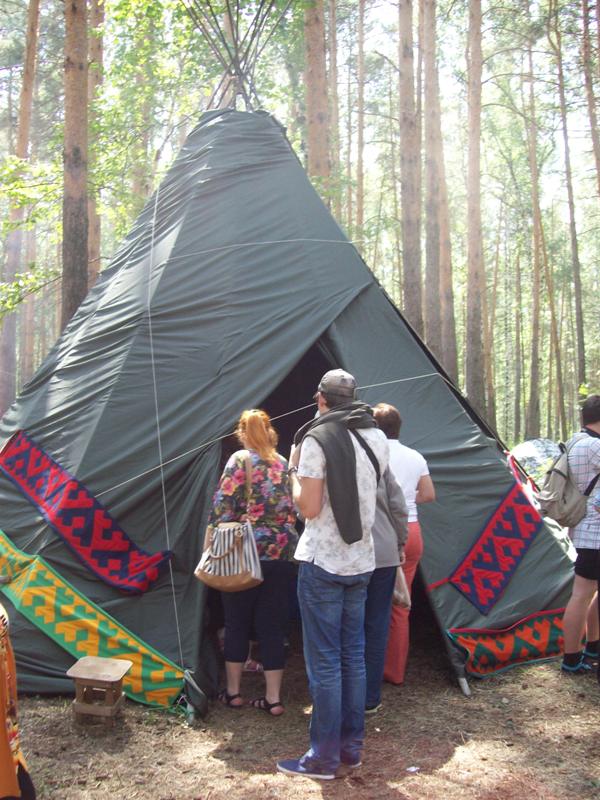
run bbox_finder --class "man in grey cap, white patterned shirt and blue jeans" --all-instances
[277,369,389,780]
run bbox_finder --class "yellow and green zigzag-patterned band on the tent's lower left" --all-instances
[0,531,183,706]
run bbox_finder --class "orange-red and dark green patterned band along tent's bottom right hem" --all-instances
[446,608,564,678]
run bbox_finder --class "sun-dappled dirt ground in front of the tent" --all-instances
[20,620,600,800]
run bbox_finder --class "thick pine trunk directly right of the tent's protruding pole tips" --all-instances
[304,0,330,181]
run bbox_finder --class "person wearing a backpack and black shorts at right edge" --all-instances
[562,394,600,680]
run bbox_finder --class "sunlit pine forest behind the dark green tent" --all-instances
[0,0,600,446]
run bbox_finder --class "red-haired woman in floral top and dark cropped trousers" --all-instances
[209,409,297,716]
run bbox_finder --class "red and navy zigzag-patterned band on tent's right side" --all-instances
[442,483,542,614]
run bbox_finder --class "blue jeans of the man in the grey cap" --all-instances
[298,561,371,772]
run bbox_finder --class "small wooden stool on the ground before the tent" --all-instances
[67,656,133,726]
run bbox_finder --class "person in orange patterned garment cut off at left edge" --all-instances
[0,603,35,800]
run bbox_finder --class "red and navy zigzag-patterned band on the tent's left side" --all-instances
[0,431,171,592]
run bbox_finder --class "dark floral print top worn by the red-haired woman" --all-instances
[209,450,298,561]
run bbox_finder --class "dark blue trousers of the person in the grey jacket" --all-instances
[365,567,397,708]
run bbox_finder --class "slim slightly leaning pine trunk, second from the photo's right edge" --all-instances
[548,0,585,386]
